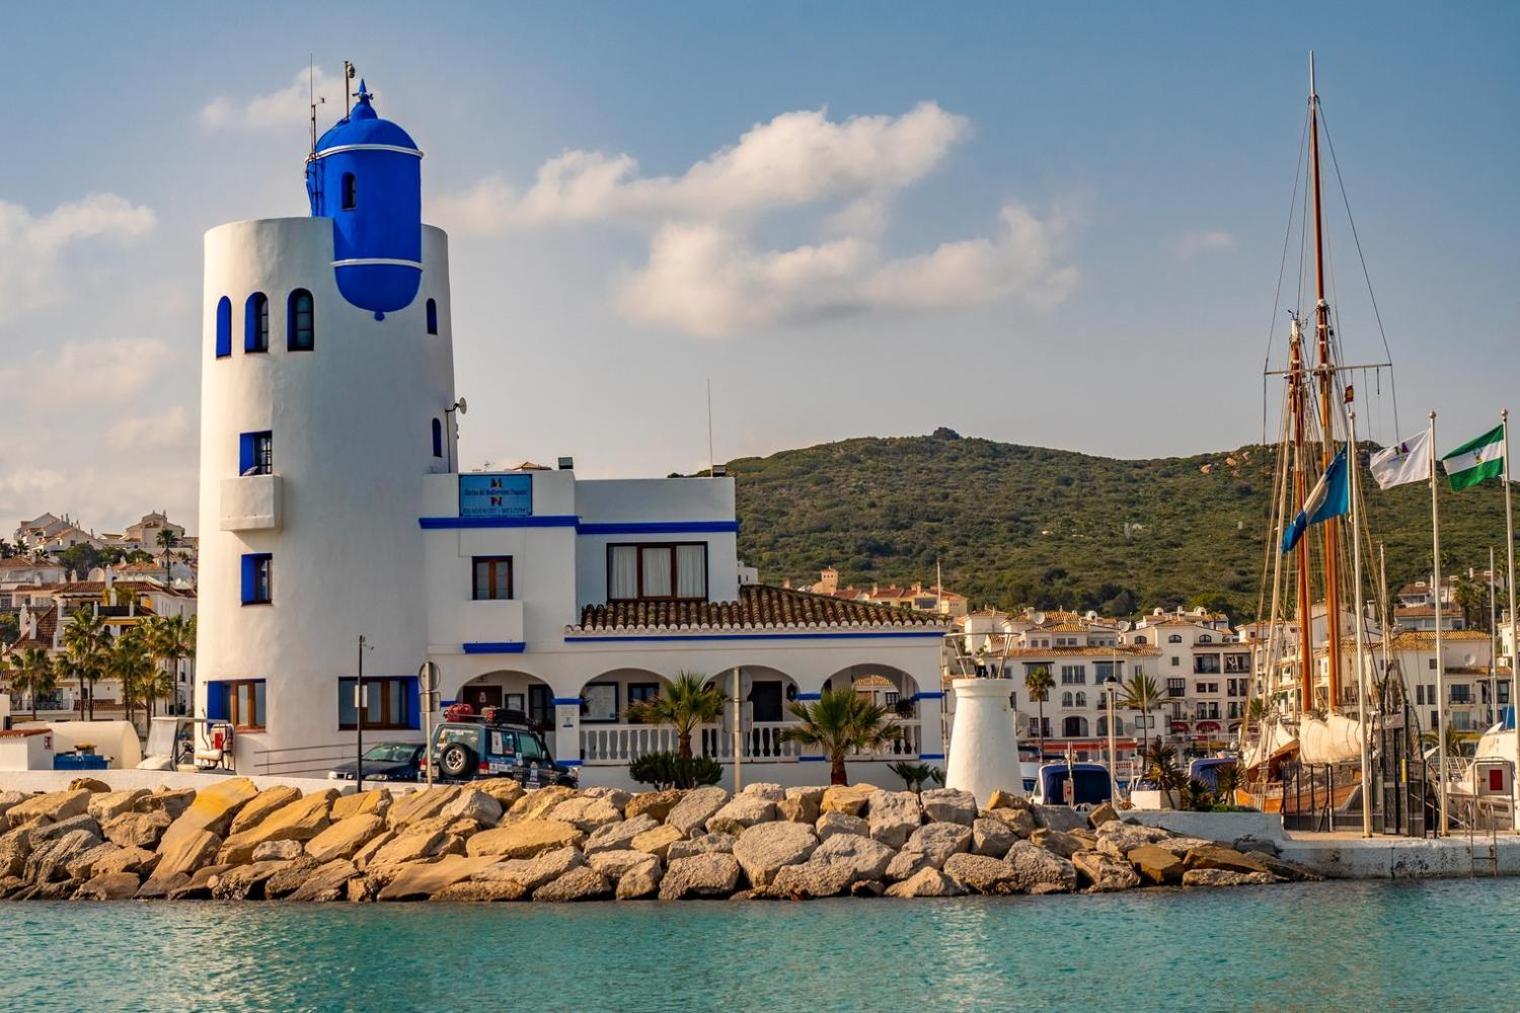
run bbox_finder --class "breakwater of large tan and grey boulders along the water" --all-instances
[0,777,1315,902]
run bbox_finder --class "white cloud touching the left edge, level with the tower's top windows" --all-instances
[0,193,158,325]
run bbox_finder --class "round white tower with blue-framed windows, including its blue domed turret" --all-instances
[196,82,454,774]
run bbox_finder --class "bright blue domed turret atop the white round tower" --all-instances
[306,81,423,319]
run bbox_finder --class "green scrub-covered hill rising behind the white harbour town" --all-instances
[728,429,1505,616]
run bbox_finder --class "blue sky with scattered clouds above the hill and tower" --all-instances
[0,0,1520,534]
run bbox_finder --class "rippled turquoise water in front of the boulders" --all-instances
[0,879,1520,1013]
